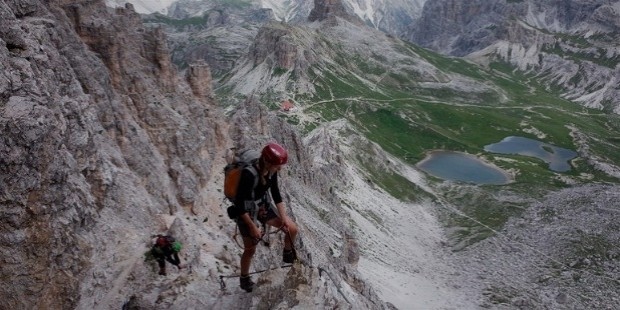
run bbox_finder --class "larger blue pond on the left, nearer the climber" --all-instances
[416,151,511,185]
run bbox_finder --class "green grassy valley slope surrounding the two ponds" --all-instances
[214,26,620,247]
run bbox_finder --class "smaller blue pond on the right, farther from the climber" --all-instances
[484,136,577,172]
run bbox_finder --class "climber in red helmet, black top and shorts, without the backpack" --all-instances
[235,143,297,292]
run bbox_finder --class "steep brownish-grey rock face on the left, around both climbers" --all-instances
[0,1,387,309]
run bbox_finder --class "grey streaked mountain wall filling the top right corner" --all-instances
[407,0,620,113]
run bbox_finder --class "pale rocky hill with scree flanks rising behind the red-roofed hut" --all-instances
[218,18,496,110]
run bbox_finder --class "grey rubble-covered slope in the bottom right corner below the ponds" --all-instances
[461,184,620,309]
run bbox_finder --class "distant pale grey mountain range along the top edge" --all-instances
[108,0,620,113]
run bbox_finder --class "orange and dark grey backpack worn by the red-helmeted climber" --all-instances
[224,150,260,219]
